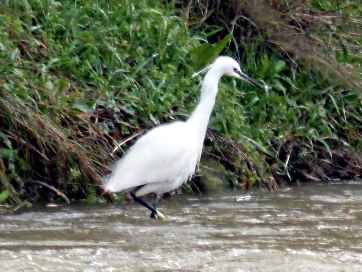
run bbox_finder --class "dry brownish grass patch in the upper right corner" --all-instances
[181,0,362,90]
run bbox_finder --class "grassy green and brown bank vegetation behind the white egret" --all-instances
[0,0,362,205]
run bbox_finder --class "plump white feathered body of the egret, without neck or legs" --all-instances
[106,122,201,196]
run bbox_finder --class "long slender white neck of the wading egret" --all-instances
[187,68,222,141]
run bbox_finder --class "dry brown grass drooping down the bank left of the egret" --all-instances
[0,93,111,203]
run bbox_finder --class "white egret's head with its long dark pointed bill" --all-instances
[211,56,265,89]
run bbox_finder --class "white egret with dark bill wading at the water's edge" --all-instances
[103,56,261,219]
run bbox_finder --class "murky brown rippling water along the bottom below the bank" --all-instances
[0,182,362,272]
